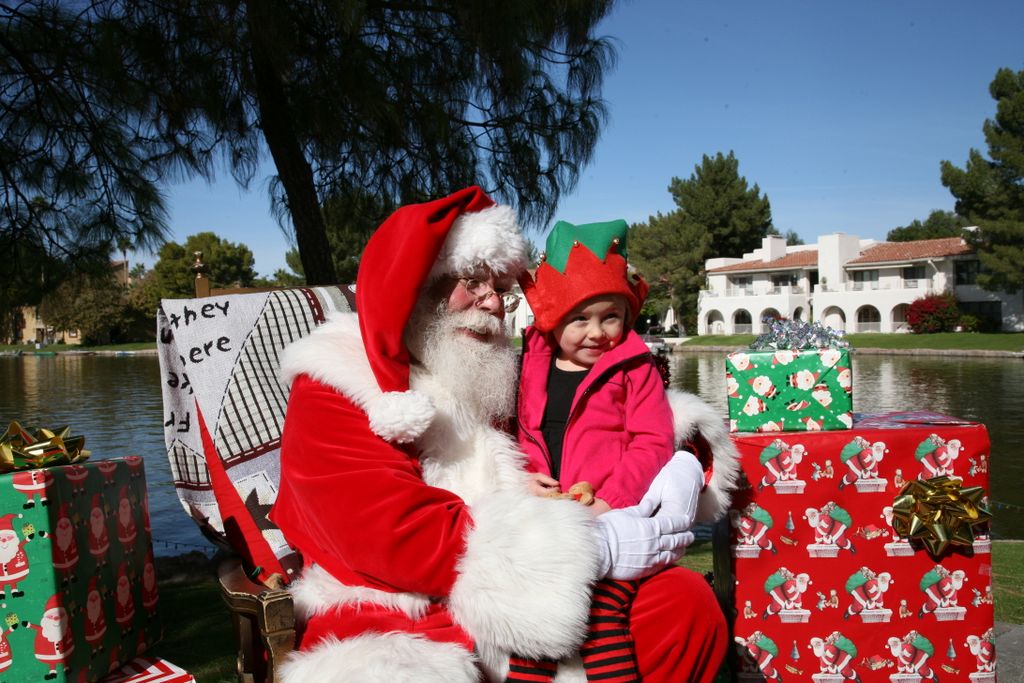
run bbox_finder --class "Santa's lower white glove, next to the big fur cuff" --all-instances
[594,502,693,581]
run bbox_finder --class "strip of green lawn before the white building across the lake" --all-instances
[683,332,1024,351]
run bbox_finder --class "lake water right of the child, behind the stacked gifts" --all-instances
[673,351,1024,539]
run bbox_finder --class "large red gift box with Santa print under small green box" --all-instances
[716,412,995,683]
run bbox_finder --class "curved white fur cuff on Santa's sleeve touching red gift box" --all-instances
[668,389,739,522]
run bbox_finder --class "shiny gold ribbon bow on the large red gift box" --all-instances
[893,476,992,556]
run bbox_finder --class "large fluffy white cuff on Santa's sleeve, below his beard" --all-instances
[450,492,597,659]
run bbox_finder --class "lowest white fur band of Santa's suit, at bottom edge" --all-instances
[281,632,480,683]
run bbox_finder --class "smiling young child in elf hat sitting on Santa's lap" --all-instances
[507,220,703,682]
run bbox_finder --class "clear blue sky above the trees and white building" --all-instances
[151,0,1024,274]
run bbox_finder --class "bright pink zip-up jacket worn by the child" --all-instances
[518,327,674,508]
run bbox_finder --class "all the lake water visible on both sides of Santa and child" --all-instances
[0,352,1024,555]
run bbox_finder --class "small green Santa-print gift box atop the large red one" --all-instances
[725,347,853,432]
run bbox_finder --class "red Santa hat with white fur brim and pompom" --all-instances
[355,187,528,442]
